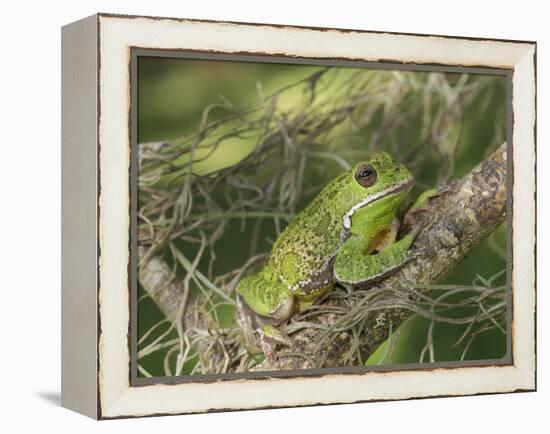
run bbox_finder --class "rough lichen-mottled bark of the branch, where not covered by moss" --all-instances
[140,143,507,371]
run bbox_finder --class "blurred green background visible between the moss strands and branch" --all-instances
[138,57,507,376]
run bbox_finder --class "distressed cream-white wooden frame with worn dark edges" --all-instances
[62,14,536,419]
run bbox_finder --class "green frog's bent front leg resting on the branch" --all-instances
[334,234,414,287]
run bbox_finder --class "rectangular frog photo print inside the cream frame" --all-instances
[131,55,511,378]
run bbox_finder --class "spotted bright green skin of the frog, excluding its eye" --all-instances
[237,152,413,324]
